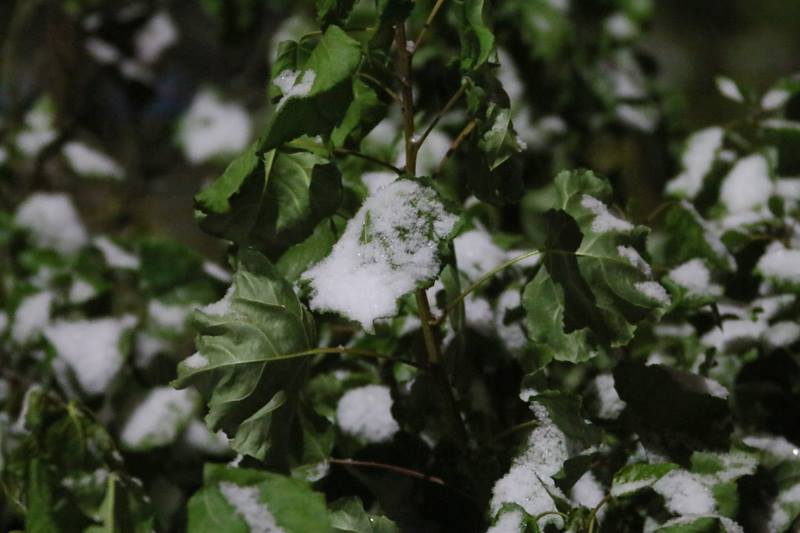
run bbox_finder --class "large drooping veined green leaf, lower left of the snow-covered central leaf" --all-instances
[175,250,316,465]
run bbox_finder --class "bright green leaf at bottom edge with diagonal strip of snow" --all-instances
[188,464,332,533]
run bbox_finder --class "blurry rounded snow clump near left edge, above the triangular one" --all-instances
[14,192,88,254]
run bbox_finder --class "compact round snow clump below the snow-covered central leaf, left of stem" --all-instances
[336,385,400,442]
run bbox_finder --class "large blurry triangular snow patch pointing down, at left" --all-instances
[44,315,136,395]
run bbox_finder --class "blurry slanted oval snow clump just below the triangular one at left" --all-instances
[120,387,195,450]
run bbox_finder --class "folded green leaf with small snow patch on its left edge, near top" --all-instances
[260,25,362,151]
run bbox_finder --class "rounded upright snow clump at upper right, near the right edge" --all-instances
[719,154,772,213]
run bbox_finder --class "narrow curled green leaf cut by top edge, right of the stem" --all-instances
[454,0,495,71]
